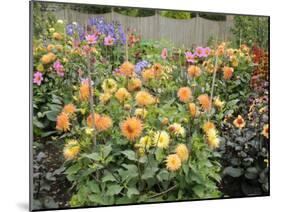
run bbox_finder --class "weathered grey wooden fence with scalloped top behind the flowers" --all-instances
[49,8,233,47]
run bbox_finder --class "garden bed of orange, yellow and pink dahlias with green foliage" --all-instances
[32,13,269,208]
